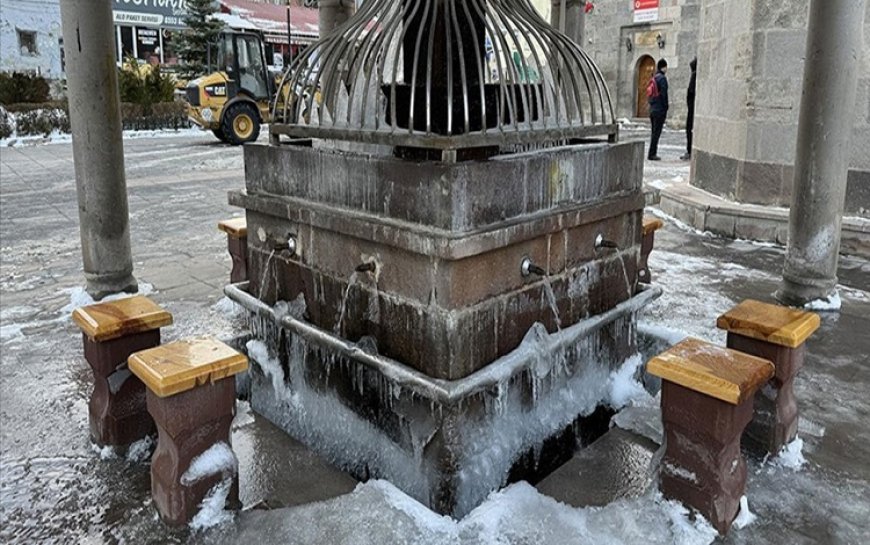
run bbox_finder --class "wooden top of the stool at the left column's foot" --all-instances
[73,295,172,342]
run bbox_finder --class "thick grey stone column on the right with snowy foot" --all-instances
[777,0,865,305]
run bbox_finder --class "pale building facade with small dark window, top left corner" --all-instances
[0,0,63,79]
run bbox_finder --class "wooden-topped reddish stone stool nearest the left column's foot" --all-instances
[72,295,172,446]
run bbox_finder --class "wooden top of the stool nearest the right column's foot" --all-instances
[716,299,821,348]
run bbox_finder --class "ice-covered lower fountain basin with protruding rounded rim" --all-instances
[226,284,660,517]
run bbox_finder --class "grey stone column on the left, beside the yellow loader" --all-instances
[60,0,136,299]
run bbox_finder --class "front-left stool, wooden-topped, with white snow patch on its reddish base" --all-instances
[128,337,248,526]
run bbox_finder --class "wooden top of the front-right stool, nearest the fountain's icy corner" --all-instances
[646,338,774,405]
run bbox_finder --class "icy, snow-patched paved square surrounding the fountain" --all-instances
[0,133,870,543]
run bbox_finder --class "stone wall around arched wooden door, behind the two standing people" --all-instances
[583,0,701,127]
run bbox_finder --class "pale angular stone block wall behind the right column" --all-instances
[692,0,870,217]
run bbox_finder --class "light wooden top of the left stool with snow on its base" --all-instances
[127,337,248,397]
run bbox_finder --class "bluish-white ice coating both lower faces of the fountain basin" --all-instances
[247,310,648,516]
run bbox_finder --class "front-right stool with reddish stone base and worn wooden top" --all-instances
[647,338,773,534]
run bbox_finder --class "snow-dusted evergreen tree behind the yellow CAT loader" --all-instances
[177,0,223,79]
